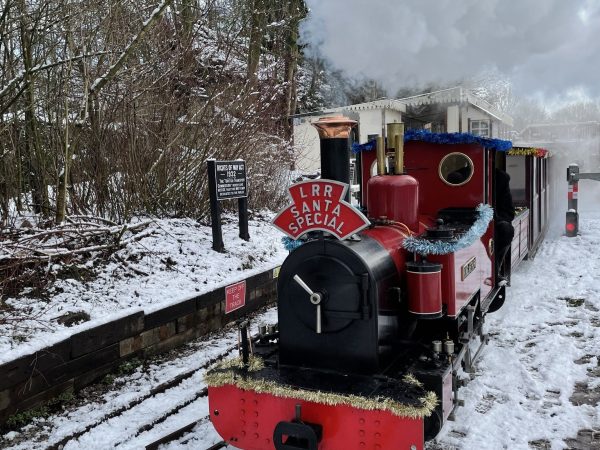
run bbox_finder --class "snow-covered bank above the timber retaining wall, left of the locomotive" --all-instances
[0,213,287,364]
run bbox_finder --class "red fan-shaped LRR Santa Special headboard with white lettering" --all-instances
[273,180,370,239]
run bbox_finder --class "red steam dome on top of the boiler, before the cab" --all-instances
[367,175,419,232]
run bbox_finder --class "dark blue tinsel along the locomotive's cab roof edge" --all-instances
[352,130,512,153]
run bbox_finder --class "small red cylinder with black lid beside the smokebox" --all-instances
[406,261,442,319]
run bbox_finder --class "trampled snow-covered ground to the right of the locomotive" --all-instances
[438,213,600,449]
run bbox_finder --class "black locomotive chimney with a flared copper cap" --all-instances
[313,116,357,202]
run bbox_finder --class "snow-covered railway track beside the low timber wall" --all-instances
[0,310,274,450]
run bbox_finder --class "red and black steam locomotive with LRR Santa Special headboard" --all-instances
[206,117,524,450]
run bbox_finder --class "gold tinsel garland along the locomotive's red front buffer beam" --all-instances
[204,357,438,419]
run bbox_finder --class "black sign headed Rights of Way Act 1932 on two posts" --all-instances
[206,159,250,252]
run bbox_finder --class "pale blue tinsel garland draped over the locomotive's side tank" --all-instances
[402,203,494,255]
